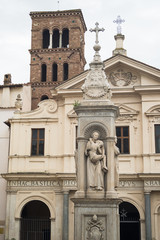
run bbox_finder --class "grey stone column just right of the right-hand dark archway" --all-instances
[144,192,152,240]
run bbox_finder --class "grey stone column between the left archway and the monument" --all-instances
[62,191,69,240]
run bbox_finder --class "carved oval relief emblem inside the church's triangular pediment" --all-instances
[108,68,138,87]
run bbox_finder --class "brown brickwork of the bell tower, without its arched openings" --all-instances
[30,10,86,109]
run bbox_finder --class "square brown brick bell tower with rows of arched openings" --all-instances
[29,9,87,109]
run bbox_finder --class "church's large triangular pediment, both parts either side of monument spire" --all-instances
[55,54,160,93]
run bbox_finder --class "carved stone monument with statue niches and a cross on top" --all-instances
[72,23,121,240]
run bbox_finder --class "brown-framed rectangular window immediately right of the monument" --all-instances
[116,126,129,154]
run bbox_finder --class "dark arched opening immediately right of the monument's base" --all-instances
[119,202,141,240]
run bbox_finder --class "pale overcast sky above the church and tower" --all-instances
[0,0,160,84]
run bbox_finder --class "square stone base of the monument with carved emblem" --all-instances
[72,198,121,240]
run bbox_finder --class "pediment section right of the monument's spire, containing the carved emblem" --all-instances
[104,54,160,88]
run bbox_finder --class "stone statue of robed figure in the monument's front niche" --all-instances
[85,131,108,191]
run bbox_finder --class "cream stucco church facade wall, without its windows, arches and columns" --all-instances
[0,55,160,240]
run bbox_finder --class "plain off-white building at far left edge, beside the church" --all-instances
[0,84,31,240]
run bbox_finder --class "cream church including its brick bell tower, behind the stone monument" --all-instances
[2,7,160,240]
